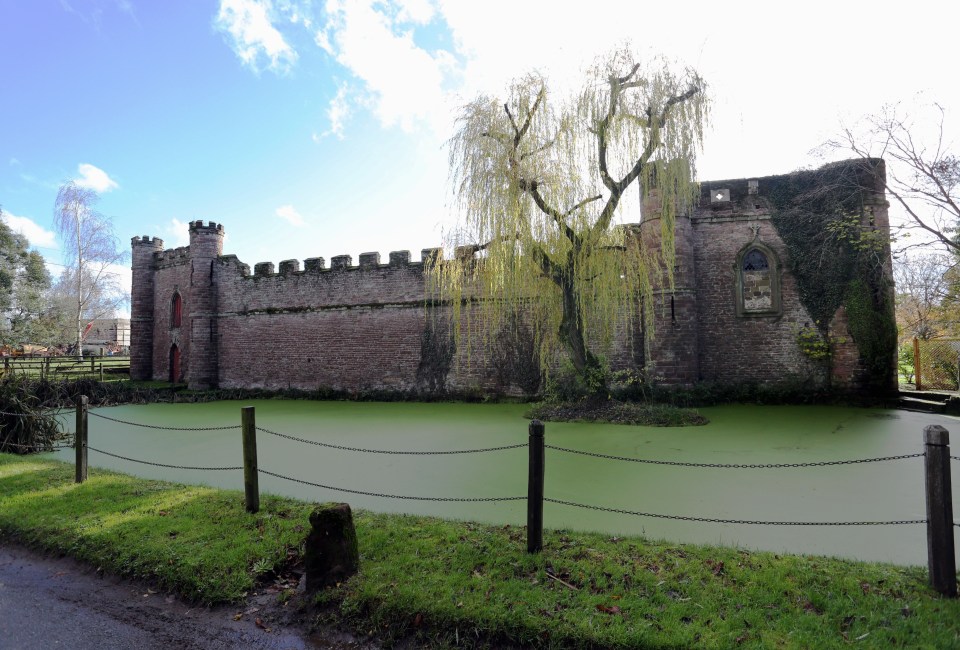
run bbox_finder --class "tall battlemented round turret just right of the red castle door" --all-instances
[187,221,223,389]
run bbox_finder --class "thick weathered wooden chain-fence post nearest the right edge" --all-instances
[923,424,957,598]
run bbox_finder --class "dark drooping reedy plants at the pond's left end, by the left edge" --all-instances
[0,375,61,454]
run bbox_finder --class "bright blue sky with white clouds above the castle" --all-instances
[0,0,960,314]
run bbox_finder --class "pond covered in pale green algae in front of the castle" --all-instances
[58,400,960,565]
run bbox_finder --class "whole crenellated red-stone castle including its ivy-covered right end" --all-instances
[130,160,895,394]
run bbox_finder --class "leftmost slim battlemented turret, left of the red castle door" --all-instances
[130,235,163,381]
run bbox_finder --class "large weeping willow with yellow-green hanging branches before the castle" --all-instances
[430,49,708,389]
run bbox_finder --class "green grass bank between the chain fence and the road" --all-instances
[0,454,960,648]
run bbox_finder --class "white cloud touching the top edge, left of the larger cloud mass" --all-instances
[214,0,301,73]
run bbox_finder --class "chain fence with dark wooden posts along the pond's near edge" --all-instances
[9,399,960,588]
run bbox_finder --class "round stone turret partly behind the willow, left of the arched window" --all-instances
[640,188,700,384]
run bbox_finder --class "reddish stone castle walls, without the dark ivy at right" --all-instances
[131,162,886,394]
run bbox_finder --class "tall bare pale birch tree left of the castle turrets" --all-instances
[54,181,126,356]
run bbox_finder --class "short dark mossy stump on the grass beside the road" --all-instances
[304,503,360,592]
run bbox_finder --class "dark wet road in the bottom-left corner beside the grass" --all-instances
[0,542,375,650]
